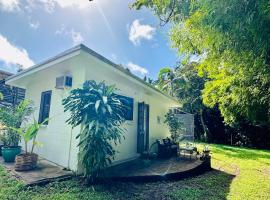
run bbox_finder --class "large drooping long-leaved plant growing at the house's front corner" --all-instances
[63,80,126,181]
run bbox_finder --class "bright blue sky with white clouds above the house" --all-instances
[0,0,177,78]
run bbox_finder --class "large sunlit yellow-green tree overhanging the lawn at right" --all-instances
[133,0,270,127]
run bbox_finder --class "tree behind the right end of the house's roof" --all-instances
[158,62,209,139]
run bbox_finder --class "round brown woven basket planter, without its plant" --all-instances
[15,153,38,171]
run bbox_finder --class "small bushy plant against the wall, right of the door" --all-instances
[164,111,184,143]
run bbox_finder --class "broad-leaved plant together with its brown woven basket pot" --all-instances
[11,119,48,171]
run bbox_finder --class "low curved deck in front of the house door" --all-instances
[100,157,211,182]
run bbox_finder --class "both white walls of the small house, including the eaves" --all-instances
[6,50,177,171]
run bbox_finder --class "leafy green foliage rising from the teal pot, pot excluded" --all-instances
[0,100,34,147]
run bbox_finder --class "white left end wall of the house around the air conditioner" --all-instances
[16,56,85,171]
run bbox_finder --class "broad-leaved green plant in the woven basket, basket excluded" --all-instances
[10,119,48,154]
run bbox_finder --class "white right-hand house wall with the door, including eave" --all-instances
[82,52,177,161]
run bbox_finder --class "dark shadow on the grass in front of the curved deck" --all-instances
[98,170,235,200]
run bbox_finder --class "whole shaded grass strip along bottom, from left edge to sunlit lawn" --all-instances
[0,166,234,200]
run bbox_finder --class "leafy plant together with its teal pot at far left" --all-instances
[0,100,33,162]
